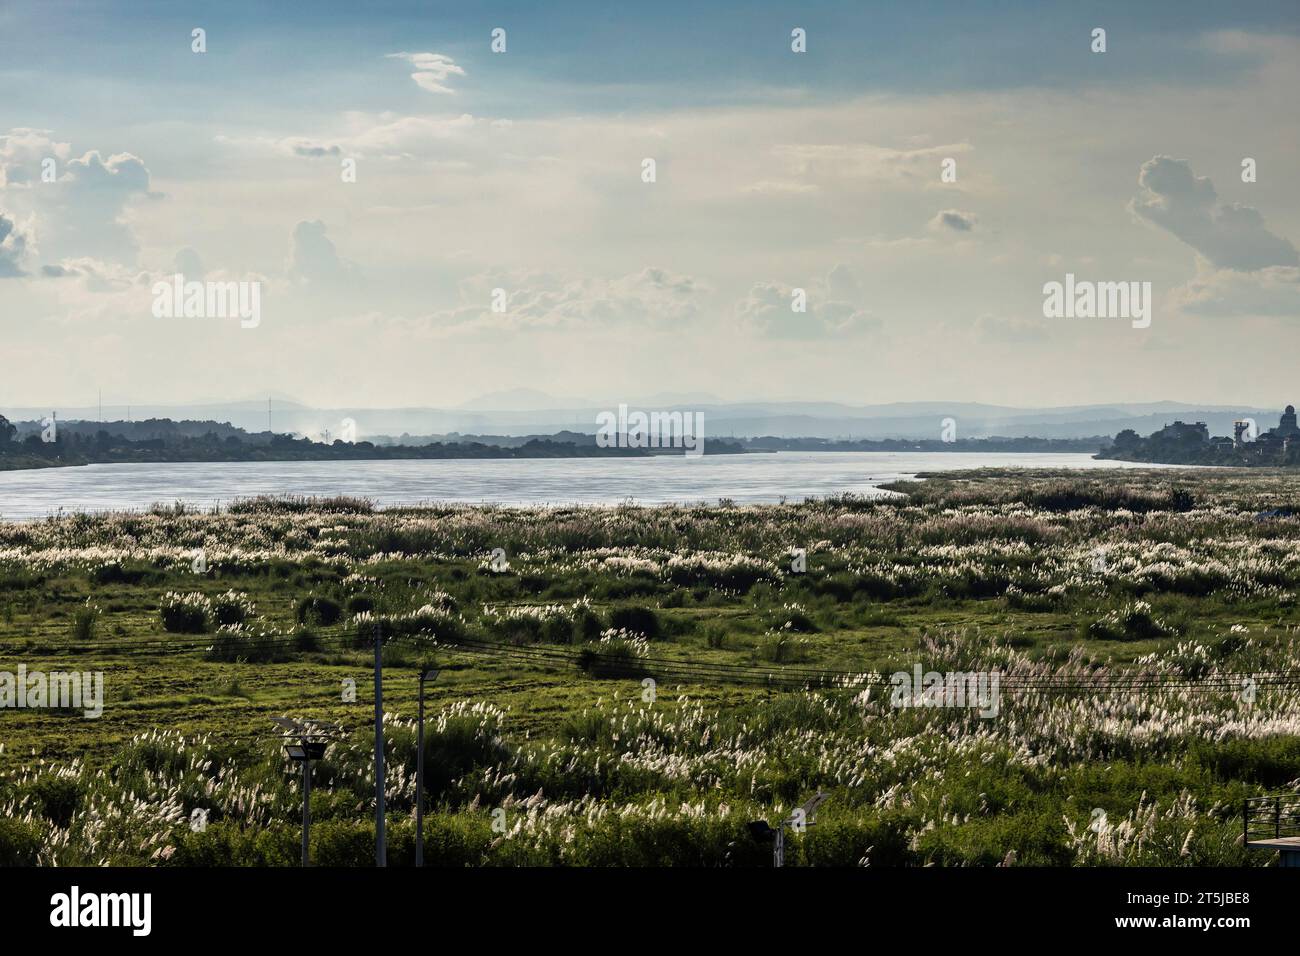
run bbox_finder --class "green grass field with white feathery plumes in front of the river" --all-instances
[0,471,1300,866]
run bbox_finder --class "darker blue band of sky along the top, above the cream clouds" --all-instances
[12,0,1300,118]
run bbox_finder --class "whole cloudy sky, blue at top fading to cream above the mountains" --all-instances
[0,0,1300,411]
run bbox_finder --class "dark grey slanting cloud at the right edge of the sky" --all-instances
[1128,156,1300,272]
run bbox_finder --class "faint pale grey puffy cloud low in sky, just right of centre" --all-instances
[733,264,883,338]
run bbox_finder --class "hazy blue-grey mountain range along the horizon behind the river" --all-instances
[0,389,1282,441]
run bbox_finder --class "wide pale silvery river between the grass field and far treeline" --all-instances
[0,451,1180,520]
